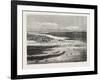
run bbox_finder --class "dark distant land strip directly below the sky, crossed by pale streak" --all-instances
[27,32,87,42]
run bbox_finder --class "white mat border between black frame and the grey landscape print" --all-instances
[17,5,94,75]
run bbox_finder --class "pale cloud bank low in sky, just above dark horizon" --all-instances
[27,22,86,32]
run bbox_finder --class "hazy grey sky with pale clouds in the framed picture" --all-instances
[27,13,87,32]
